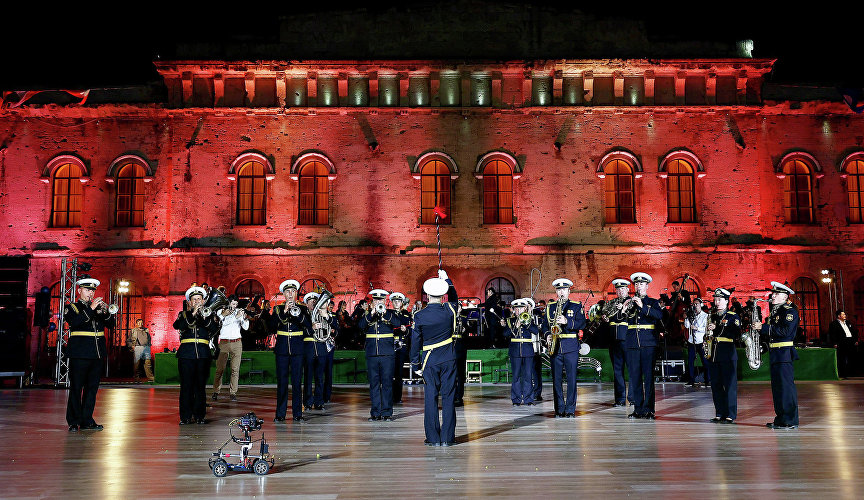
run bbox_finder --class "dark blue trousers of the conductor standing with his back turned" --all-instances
[423,360,456,443]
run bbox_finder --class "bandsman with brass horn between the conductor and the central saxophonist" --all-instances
[501,298,540,406]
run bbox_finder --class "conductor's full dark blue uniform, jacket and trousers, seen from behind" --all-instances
[411,280,457,445]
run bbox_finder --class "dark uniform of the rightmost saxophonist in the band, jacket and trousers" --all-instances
[762,304,799,426]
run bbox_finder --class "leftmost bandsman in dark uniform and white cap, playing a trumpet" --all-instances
[63,274,114,432]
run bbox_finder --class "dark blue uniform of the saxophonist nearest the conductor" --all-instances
[540,300,586,415]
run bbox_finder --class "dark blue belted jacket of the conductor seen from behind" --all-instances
[411,279,458,370]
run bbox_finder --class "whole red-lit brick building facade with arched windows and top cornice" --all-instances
[0,58,864,356]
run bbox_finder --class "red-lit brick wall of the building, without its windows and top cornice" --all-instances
[0,59,864,349]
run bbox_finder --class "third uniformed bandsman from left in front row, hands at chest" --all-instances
[264,279,312,422]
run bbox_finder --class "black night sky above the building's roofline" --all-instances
[0,0,864,90]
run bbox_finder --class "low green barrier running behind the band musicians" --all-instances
[154,347,839,384]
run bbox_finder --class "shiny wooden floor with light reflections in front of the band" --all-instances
[0,381,864,499]
